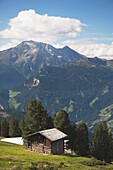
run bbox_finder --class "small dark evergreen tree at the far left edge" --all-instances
[1,118,9,137]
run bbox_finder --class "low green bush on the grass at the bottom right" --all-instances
[82,158,107,166]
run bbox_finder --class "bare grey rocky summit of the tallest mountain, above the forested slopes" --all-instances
[0,41,86,78]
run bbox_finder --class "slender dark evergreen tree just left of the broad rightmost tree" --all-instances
[76,122,89,156]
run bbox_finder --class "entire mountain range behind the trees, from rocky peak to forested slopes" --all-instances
[0,41,113,128]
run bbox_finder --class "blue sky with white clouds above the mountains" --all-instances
[0,0,113,60]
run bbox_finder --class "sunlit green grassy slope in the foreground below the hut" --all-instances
[0,142,113,170]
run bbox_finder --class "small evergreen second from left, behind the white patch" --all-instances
[9,117,20,137]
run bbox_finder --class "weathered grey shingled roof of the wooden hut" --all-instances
[28,128,67,141]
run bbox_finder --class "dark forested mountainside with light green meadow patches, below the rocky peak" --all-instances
[12,59,113,126]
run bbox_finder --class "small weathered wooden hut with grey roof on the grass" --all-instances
[27,128,67,155]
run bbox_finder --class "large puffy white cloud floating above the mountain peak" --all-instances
[0,9,85,43]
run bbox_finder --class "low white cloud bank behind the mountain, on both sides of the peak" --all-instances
[0,39,113,60]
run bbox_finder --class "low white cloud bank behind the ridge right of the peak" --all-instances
[62,40,113,60]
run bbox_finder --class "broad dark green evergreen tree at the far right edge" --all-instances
[91,122,113,163]
